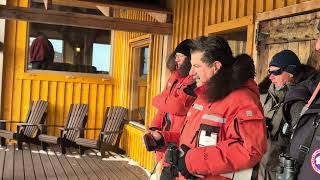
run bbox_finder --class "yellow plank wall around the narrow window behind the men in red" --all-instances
[114,10,165,170]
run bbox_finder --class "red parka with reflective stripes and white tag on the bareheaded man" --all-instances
[162,79,267,180]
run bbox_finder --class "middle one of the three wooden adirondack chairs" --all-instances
[39,104,88,154]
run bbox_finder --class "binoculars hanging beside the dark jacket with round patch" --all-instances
[276,154,297,180]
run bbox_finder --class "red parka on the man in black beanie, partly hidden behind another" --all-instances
[149,71,195,161]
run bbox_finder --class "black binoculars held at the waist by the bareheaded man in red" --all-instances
[165,143,180,177]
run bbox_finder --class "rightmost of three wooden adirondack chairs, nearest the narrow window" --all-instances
[76,106,128,157]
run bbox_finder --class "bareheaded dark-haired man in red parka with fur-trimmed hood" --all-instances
[148,36,267,180]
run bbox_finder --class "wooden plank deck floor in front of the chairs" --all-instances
[0,144,148,180]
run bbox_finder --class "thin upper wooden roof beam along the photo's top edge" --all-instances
[33,0,173,15]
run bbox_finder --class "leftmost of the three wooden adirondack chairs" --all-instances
[0,100,48,149]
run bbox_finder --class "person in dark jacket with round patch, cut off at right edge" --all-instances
[283,33,320,180]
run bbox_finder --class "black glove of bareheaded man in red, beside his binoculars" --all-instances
[178,144,196,179]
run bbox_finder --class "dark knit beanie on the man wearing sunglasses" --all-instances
[269,50,301,76]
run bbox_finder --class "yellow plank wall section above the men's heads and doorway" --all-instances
[173,0,308,47]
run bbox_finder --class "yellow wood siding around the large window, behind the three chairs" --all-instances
[1,0,114,139]
